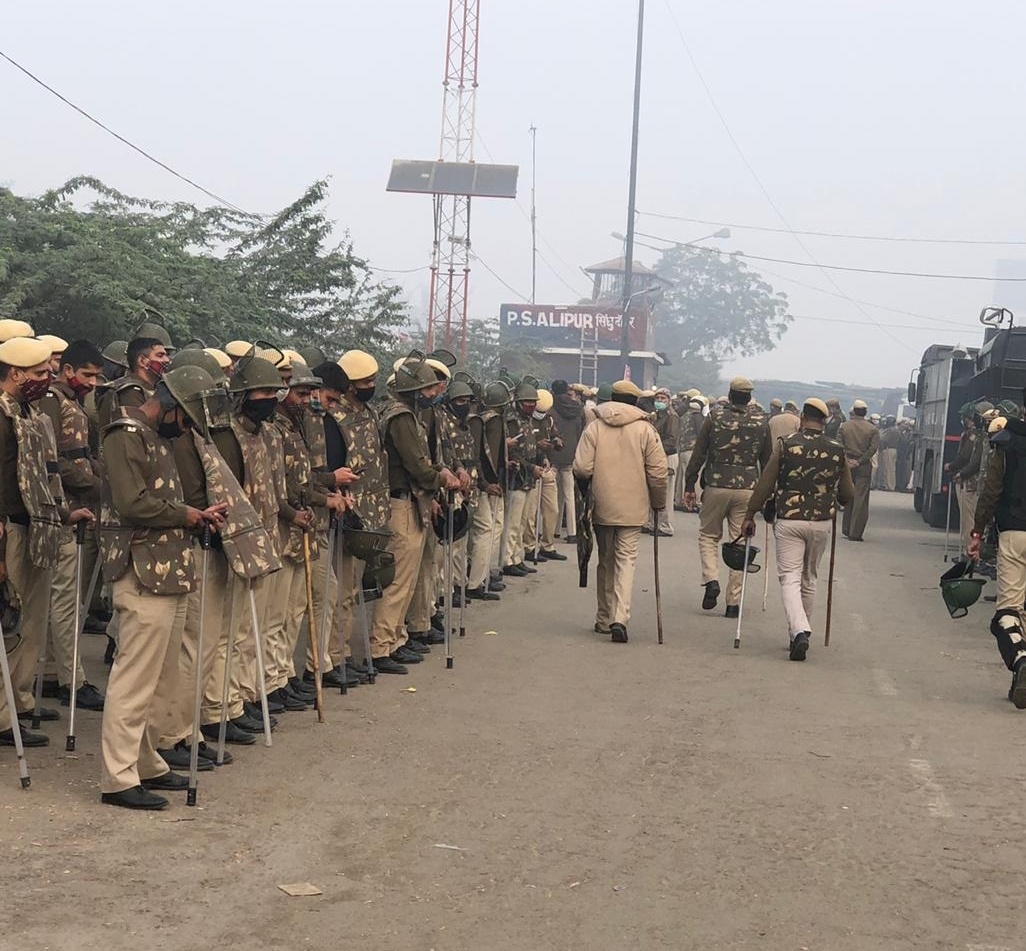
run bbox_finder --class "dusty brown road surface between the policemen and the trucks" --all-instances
[0,492,1026,951]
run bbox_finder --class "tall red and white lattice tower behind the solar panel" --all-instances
[427,0,481,359]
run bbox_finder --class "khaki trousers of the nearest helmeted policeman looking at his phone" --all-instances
[100,567,189,792]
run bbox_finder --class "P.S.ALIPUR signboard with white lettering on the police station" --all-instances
[499,304,645,351]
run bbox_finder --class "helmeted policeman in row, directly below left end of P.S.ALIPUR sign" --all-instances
[467,381,512,601]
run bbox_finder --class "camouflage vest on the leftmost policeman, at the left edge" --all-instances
[0,392,64,568]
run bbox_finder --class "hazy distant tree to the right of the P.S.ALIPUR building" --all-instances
[653,244,791,392]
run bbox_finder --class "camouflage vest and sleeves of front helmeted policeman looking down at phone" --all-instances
[100,408,196,595]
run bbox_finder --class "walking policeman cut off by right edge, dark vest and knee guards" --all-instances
[965,406,1026,710]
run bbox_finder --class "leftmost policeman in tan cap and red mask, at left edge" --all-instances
[0,338,92,746]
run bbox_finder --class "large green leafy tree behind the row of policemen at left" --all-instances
[0,177,407,360]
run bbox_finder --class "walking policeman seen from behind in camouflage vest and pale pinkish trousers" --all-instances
[744,399,855,661]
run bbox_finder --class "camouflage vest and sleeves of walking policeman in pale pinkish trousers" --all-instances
[748,430,855,522]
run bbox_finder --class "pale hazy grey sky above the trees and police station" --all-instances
[8,0,1026,386]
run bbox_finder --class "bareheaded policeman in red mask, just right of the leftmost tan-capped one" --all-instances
[39,341,104,710]
